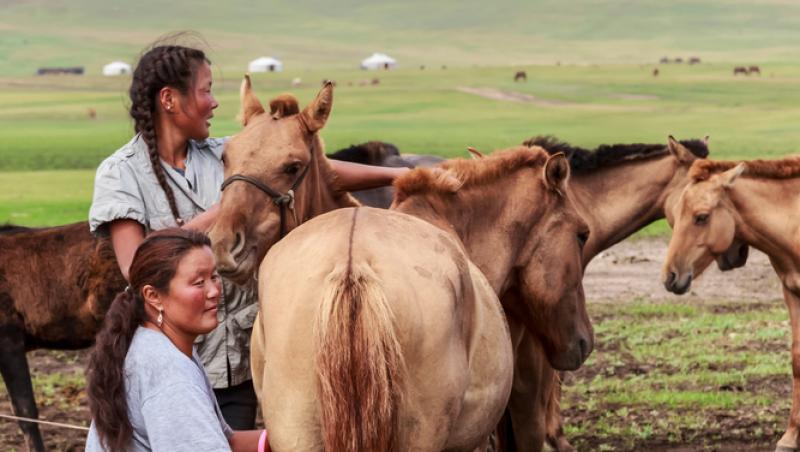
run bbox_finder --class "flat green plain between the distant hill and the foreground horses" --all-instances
[0,63,800,228]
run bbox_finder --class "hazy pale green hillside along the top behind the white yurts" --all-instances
[0,0,800,77]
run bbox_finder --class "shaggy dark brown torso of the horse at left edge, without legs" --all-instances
[0,222,124,349]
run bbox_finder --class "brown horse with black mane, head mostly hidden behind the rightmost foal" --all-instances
[510,132,748,451]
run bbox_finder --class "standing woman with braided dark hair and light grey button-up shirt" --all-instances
[89,45,406,430]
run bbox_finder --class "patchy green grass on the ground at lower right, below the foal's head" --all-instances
[562,300,791,450]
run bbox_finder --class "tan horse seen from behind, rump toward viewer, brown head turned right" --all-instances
[253,148,591,450]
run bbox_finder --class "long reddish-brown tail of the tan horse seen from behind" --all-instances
[314,263,404,452]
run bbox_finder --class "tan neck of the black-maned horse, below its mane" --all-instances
[569,154,678,264]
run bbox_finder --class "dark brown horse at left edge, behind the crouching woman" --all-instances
[0,222,125,451]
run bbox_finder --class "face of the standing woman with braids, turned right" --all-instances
[175,61,219,140]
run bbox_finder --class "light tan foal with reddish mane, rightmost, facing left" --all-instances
[663,157,800,452]
